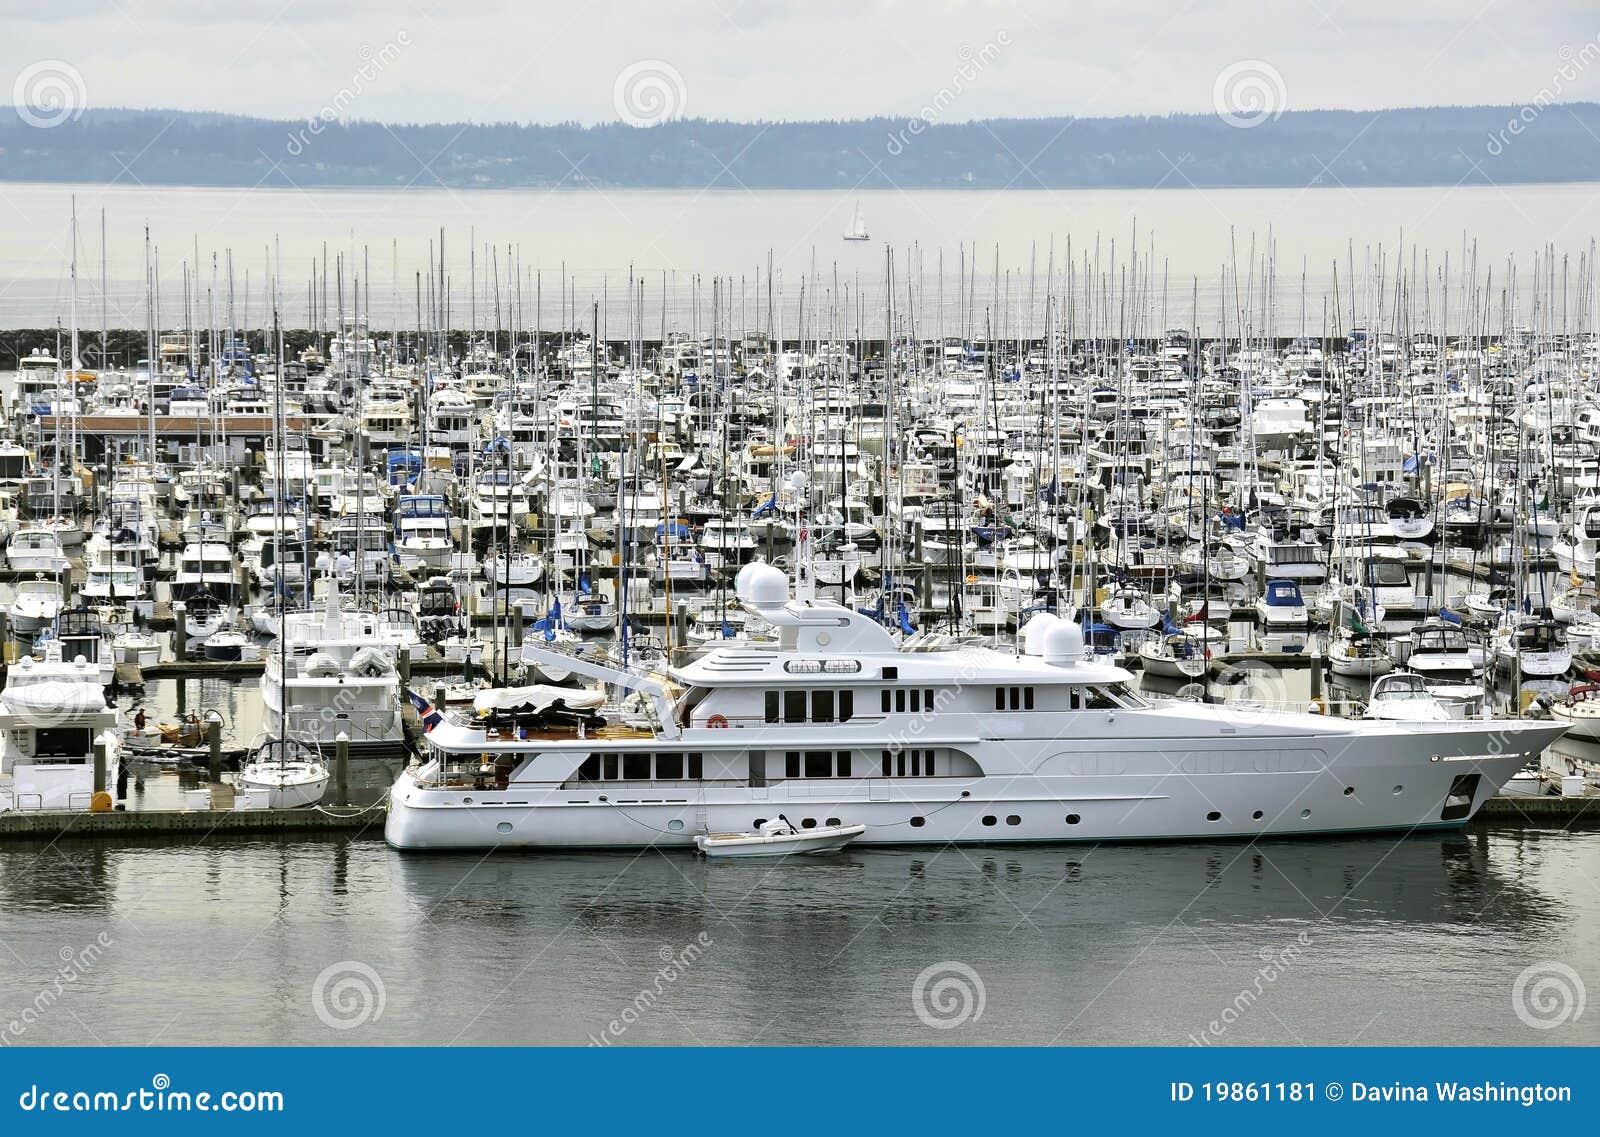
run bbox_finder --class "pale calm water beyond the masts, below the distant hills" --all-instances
[0,182,1600,339]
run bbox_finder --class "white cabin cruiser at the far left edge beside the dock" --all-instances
[0,640,122,812]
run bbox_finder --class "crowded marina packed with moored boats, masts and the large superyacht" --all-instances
[0,201,1600,851]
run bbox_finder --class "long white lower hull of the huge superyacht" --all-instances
[384,712,1563,849]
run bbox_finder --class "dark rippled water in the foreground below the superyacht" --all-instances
[0,830,1600,1044]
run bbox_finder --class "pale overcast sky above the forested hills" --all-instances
[0,0,1600,123]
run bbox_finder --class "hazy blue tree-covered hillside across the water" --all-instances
[0,102,1600,189]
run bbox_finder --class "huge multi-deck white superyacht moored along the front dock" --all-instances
[386,563,1563,849]
